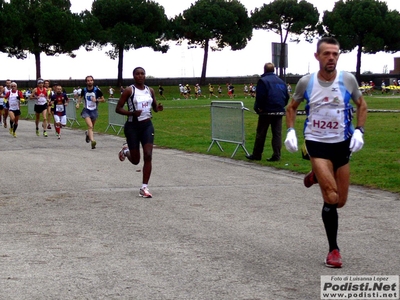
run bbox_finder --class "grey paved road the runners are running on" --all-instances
[0,121,400,300]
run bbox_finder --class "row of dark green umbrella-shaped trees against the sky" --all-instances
[0,0,400,85]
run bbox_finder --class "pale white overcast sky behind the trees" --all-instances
[0,0,400,80]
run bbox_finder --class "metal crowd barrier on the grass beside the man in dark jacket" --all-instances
[207,101,249,157]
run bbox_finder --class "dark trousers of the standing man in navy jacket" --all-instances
[253,115,282,159]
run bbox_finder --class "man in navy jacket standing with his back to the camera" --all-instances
[246,63,289,161]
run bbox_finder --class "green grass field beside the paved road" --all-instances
[22,86,400,193]
